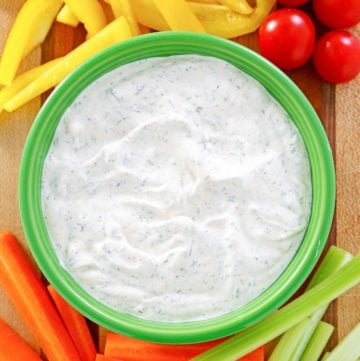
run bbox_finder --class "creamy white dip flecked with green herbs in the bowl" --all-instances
[42,55,311,322]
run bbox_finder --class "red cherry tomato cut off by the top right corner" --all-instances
[313,0,360,29]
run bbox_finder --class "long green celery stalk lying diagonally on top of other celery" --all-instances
[192,253,360,361]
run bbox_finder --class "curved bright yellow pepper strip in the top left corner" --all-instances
[0,0,63,86]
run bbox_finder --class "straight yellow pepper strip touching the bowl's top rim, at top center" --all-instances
[153,0,205,33]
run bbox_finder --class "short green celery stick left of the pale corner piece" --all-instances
[301,321,334,361]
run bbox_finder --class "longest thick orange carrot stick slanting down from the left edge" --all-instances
[0,232,81,361]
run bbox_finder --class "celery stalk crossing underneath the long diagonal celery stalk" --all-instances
[273,246,352,361]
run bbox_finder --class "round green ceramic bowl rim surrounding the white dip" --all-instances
[19,32,335,343]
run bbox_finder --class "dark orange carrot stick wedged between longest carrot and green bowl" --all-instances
[47,285,96,361]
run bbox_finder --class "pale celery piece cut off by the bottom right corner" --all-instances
[326,323,360,361]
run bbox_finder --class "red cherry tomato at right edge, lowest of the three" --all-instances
[313,30,360,84]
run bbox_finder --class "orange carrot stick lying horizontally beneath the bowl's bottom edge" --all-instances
[104,332,264,361]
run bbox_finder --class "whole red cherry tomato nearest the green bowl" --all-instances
[258,9,316,70]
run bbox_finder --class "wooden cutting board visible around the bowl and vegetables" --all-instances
[0,0,360,351]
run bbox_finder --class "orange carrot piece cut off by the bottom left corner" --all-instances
[0,320,41,361]
